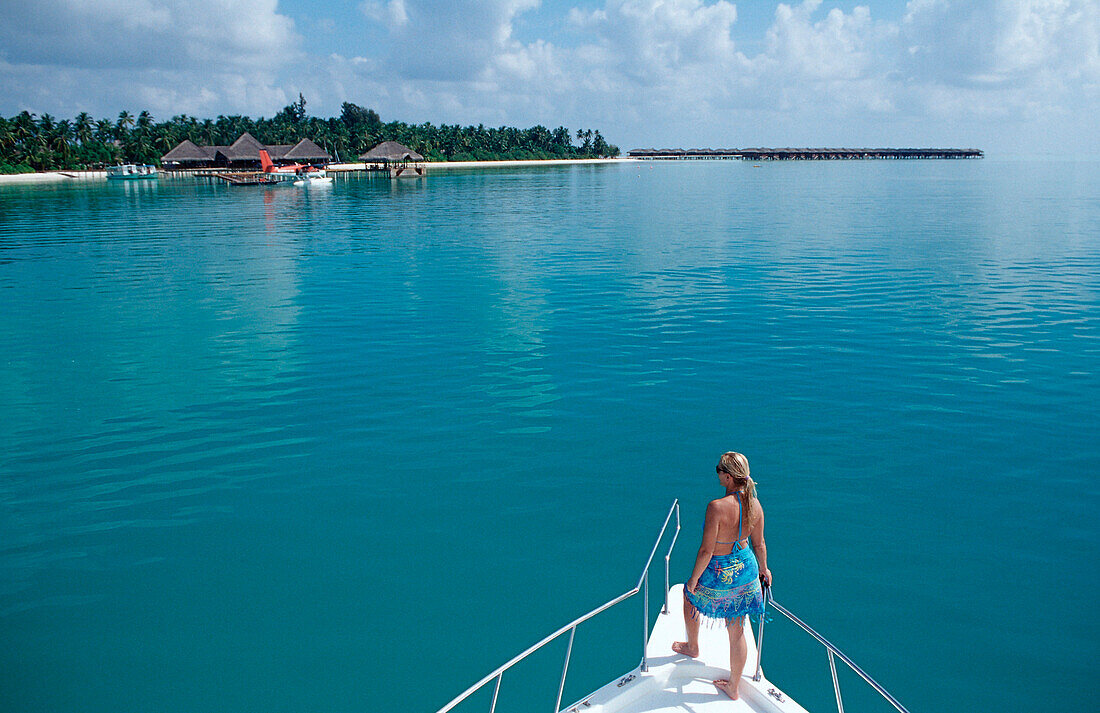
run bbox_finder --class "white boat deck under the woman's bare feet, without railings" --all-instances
[564,584,805,713]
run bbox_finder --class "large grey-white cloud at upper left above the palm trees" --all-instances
[0,0,303,117]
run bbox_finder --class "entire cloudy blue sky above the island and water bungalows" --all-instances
[0,0,1100,158]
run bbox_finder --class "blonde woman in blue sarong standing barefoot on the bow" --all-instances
[672,452,771,700]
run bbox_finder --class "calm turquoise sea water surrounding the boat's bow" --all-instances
[0,160,1100,713]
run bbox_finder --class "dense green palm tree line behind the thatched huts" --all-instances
[0,95,619,173]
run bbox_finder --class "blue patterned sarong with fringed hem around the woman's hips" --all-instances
[684,547,763,625]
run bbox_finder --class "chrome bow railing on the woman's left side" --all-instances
[438,500,677,713]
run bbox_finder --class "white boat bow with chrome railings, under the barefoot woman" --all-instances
[438,501,909,713]
